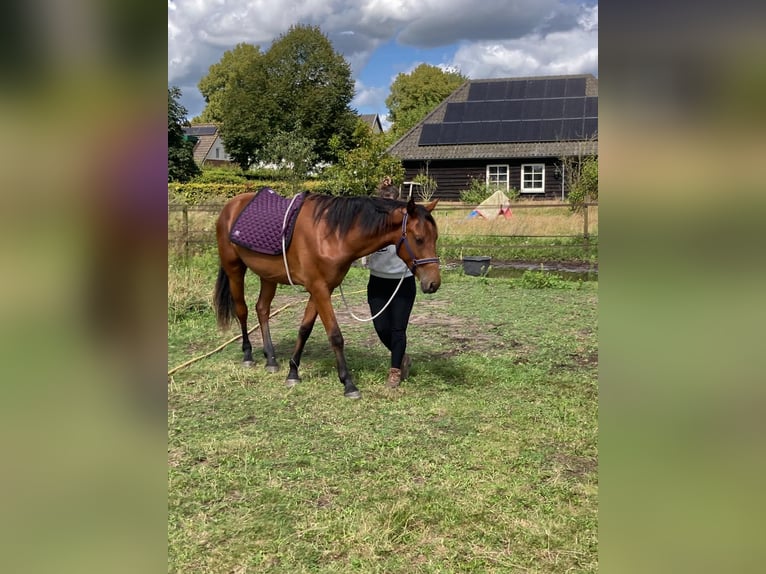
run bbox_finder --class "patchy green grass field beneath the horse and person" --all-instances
[168,255,598,573]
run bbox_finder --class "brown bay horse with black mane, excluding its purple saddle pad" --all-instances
[214,193,441,399]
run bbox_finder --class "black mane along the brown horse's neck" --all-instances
[306,194,412,237]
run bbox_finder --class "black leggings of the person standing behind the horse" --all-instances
[367,275,416,369]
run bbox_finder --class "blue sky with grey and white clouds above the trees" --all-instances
[168,0,598,125]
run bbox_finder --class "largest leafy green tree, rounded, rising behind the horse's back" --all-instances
[199,25,356,168]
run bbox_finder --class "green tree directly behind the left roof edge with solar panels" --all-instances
[386,64,468,138]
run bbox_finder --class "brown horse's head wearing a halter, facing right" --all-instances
[396,198,442,293]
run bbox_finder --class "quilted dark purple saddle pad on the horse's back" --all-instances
[229,187,305,255]
